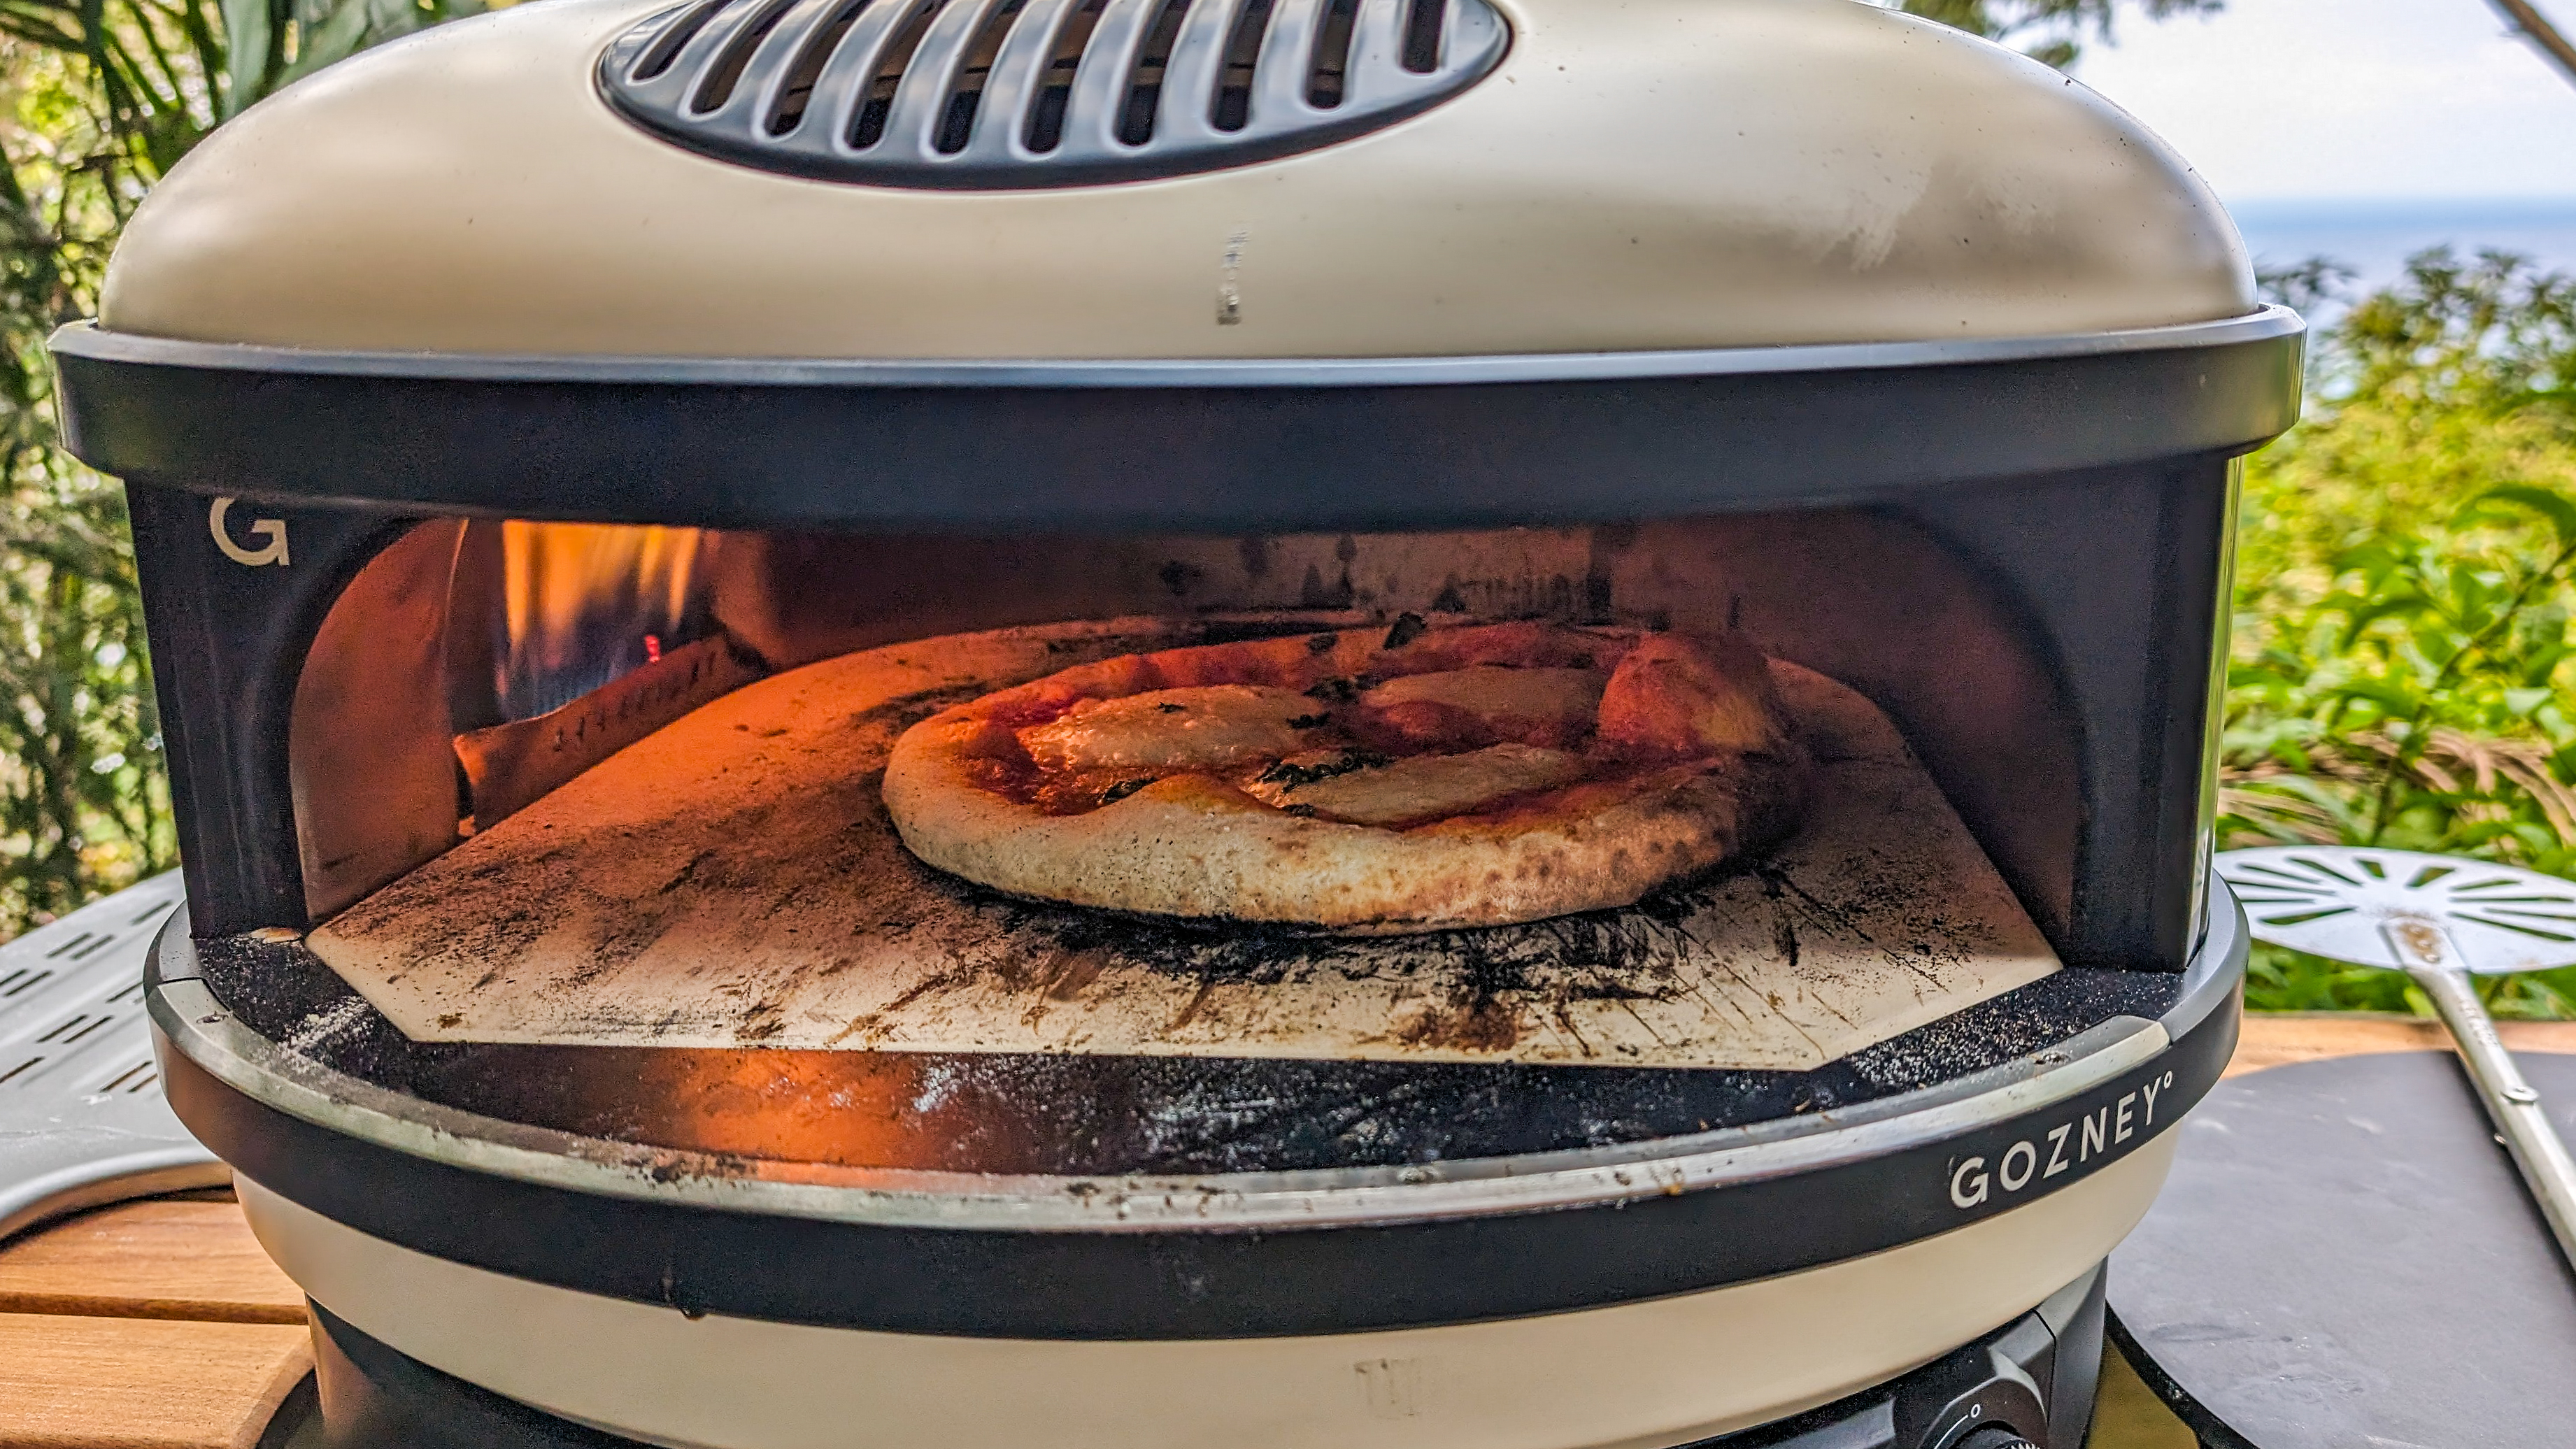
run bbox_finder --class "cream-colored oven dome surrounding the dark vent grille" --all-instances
[101,0,2254,358]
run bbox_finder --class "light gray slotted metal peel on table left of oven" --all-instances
[0,870,232,1238]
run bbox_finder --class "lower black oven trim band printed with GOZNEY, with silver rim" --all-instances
[147,911,2247,1339]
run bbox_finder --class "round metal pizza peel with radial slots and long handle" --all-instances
[2215,844,2576,1266]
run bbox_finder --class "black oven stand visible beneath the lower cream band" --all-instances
[306,1266,2107,1449]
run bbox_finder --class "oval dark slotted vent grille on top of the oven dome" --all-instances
[600,0,1512,190]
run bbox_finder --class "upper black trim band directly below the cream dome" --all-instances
[52,306,2303,530]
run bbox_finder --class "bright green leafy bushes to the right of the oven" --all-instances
[2221,250,2576,1017]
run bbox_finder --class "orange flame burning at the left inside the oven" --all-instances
[492,520,716,720]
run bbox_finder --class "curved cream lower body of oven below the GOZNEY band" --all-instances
[240,1132,2172,1449]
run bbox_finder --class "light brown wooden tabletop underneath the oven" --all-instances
[0,1014,2576,1449]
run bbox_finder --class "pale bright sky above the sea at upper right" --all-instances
[2076,0,2576,206]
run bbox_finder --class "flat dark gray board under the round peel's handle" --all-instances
[2109,1052,2576,1449]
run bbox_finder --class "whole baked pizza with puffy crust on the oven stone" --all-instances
[883,615,1806,934]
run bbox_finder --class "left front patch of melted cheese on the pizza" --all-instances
[1020,685,1324,772]
